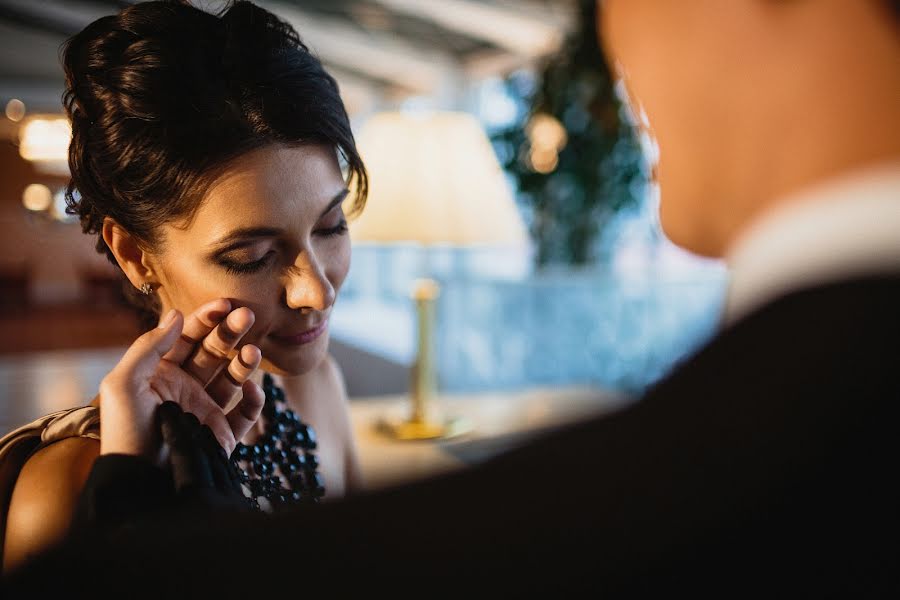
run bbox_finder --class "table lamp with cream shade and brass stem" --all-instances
[350,112,527,440]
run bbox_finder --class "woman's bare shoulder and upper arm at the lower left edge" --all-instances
[3,437,100,571]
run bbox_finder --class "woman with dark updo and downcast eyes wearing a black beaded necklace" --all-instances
[3,2,367,569]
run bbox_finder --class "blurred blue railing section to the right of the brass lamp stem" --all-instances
[437,274,723,393]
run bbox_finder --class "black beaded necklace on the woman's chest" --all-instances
[231,373,325,512]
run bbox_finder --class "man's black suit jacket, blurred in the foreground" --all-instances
[6,277,900,597]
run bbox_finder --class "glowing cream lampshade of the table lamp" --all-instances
[350,112,527,245]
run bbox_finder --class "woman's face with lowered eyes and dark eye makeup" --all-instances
[153,145,350,375]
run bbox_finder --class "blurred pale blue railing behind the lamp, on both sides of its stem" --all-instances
[332,248,726,394]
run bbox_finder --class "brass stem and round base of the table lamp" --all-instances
[381,279,468,440]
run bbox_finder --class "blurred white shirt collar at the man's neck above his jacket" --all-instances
[725,162,900,324]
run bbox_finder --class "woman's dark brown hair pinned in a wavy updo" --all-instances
[63,1,368,324]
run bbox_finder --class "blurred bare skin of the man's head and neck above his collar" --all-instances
[599,0,900,256]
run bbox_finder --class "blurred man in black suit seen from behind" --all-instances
[8,0,900,597]
